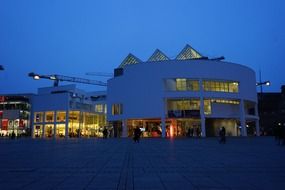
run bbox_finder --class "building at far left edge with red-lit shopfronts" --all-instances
[0,94,33,136]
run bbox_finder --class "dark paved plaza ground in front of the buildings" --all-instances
[0,137,285,190]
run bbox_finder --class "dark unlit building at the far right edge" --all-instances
[258,85,285,135]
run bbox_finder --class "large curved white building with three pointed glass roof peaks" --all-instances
[107,45,259,137]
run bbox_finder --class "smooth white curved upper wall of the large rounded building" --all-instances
[107,60,257,121]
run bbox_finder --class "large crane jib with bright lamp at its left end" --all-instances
[28,72,107,86]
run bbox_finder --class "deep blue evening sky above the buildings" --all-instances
[0,0,285,93]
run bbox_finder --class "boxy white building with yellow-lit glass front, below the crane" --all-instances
[31,85,107,138]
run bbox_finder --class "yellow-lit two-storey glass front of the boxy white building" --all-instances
[33,110,107,138]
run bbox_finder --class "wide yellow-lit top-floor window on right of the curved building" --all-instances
[203,81,239,93]
